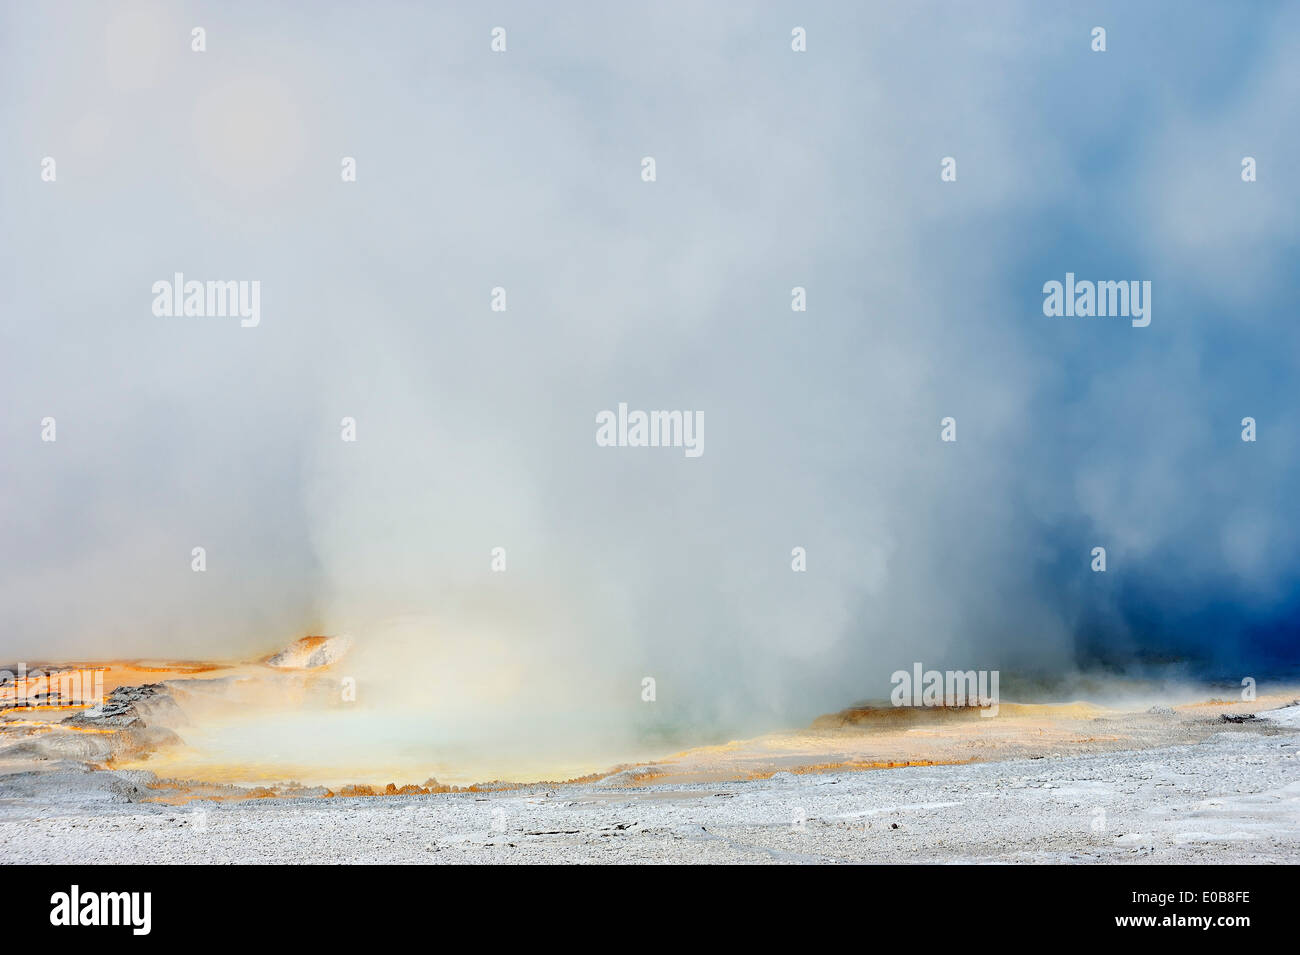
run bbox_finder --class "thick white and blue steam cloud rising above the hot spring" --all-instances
[0,3,1300,732]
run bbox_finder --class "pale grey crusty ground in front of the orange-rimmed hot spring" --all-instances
[0,707,1300,863]
